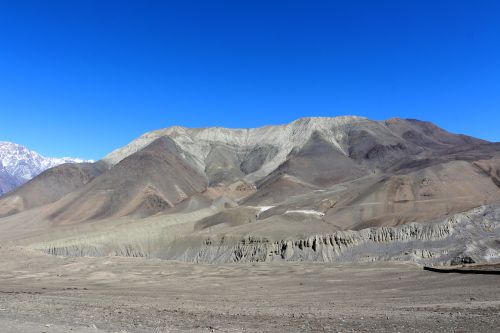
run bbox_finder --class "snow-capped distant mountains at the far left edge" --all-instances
[0,141,91,196]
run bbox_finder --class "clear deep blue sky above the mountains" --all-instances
[0,0,500,159]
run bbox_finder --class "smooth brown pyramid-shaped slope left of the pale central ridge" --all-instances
[47,137,207,223]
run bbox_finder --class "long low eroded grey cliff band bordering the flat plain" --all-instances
[34,207,500,265]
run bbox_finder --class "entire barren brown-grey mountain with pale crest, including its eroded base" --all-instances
[0,116,500,263]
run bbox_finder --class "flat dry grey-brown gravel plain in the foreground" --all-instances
[0,247,500,333]
